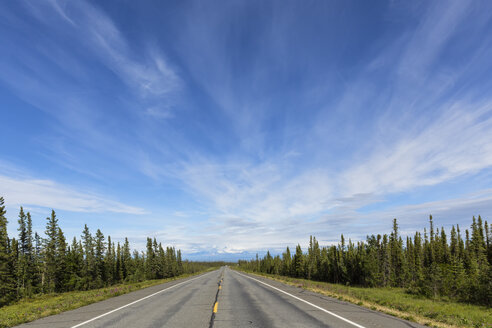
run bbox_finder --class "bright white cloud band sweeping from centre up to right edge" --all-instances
[163,98,492,227]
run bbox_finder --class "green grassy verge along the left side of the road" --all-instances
[0,268,217,328]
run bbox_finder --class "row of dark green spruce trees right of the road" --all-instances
[239,216,492,306]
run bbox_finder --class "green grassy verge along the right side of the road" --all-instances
[232,267,492,328]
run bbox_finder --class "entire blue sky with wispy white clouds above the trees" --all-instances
[0,0,492,259]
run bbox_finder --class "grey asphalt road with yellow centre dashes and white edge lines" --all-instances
[18,268,424,328]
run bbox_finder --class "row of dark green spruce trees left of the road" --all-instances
[0,197,209,306]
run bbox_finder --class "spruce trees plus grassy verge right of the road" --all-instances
[238,216,492,327]
